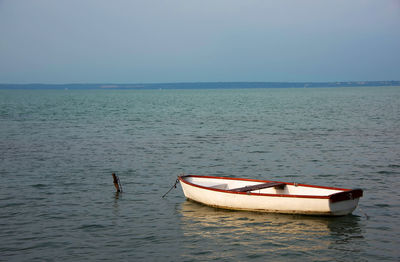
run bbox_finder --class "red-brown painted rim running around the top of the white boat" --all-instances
[178,175,352,199]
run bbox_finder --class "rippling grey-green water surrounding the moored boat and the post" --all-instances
[0,86,400,261]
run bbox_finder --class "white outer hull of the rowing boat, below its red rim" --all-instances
[179,176,359,216]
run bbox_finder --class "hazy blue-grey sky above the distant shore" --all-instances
[0,0,400,84]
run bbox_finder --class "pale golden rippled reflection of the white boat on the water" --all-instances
[179,201,363,260]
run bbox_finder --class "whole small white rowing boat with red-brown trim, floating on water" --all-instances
[177,175,363,216]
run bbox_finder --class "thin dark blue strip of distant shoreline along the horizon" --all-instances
[0,81,400,90]
